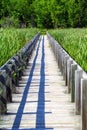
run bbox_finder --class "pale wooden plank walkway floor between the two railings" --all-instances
[0,36,81,130]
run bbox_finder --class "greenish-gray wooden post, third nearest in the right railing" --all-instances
[70,64,77,102]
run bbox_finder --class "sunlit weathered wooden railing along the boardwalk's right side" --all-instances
[47,33,87,130]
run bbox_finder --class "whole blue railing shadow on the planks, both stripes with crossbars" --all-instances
[3,37,53,130]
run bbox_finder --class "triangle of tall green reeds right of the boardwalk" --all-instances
[49,29,87,72]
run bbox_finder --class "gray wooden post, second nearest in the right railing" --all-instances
[75,70,83,115]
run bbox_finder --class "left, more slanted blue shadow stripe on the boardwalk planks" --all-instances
[12,38,40,130]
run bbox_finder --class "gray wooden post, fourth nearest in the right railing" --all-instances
[67,59,73,93]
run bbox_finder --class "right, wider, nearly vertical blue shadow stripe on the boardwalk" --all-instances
[36,37,45,128]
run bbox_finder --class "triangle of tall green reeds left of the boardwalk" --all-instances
[0,28,39,66]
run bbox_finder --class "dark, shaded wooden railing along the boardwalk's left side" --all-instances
[0,33,40,114]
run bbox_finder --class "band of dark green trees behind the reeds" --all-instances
[0,0,87,28]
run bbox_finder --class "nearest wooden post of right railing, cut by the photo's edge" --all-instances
[81,79,87,130]
